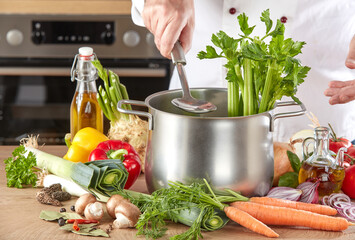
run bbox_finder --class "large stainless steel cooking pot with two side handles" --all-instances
[117,88,306,196]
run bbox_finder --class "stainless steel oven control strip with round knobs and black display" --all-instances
[0,14,164,60]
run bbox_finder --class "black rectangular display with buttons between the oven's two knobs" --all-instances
[32,21,115,45]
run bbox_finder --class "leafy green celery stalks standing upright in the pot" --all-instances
[198,9,310,117]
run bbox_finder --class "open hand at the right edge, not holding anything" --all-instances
[324,35,355,105]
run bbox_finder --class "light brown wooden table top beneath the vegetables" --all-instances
[0,146,355,240]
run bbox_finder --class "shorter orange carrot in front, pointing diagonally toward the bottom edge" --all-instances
[224,207,279,237]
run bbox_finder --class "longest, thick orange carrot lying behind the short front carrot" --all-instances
[231,202,352,231]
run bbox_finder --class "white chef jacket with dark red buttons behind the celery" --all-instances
[132,0,355,141]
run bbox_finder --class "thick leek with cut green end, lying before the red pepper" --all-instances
[25,147,128,196]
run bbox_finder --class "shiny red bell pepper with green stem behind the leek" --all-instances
[89,140,141,189]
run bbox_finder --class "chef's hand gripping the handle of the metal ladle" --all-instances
[142,0,195,58]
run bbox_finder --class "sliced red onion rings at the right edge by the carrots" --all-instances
[322,193,355,222]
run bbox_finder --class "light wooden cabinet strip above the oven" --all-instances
[0,0,131,15]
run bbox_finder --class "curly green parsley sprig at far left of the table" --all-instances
[4,145,37,188]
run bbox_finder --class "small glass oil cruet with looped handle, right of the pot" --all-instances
[298,127,345,197]
